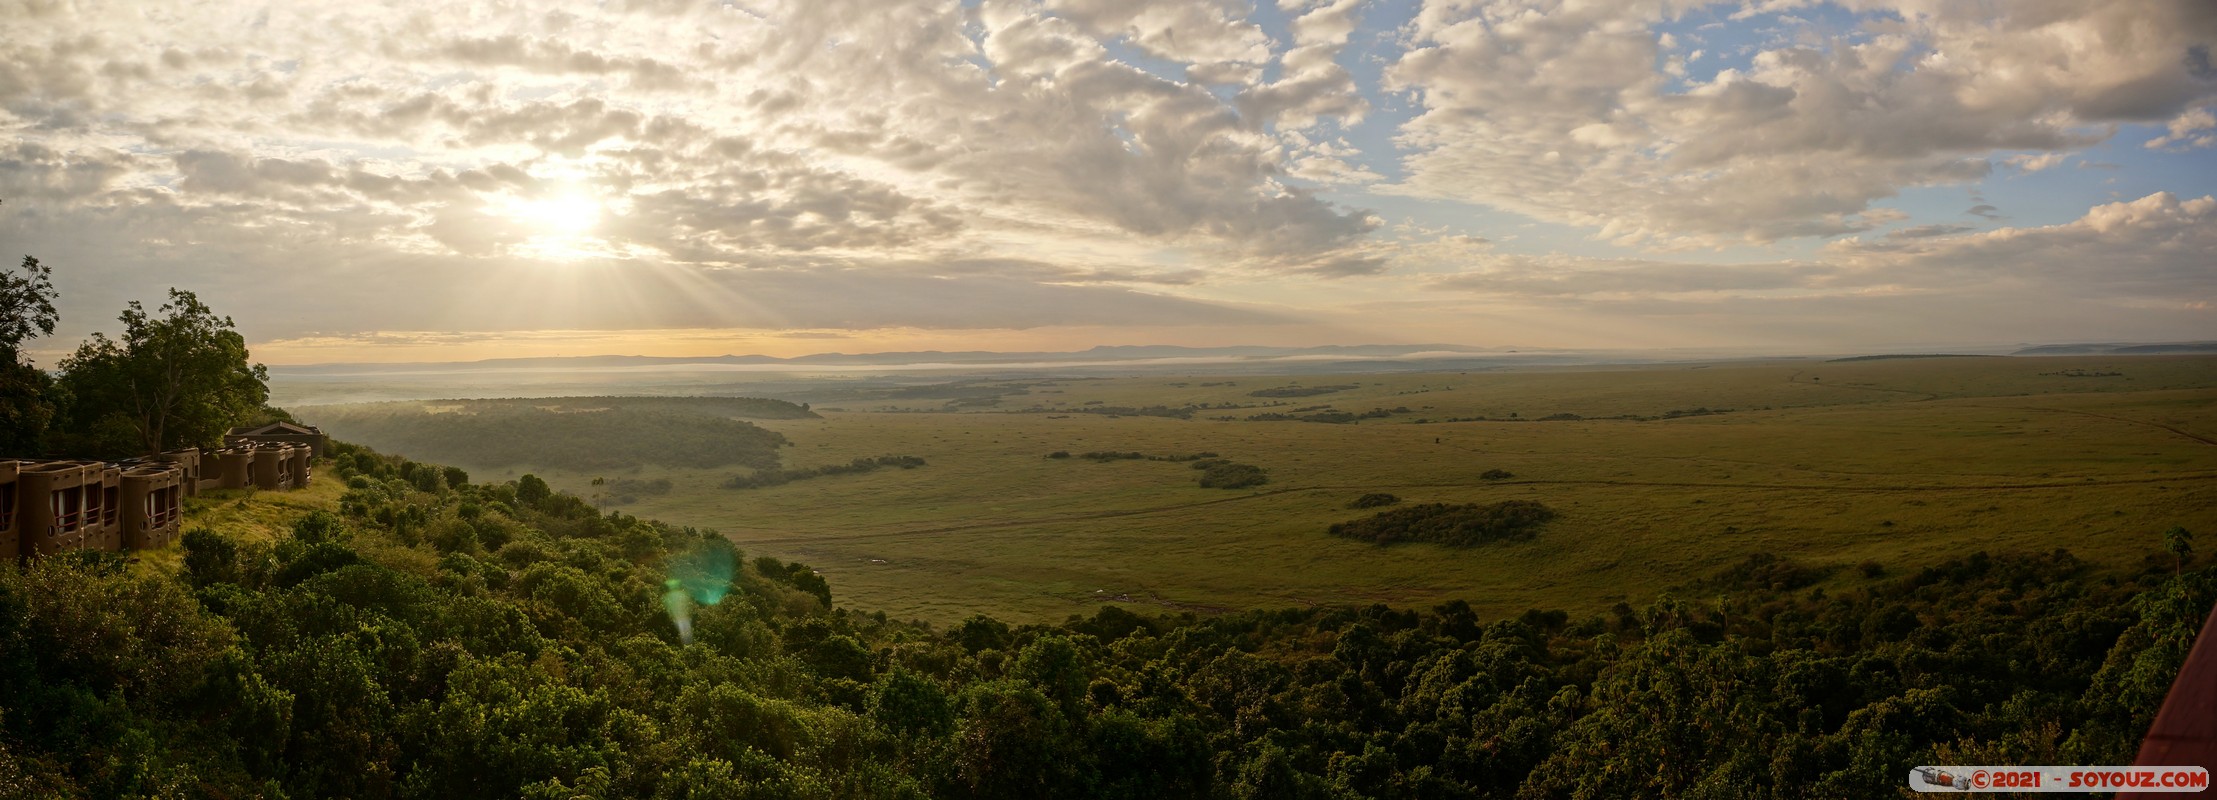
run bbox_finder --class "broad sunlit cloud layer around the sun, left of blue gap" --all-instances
[0,0,1379,350]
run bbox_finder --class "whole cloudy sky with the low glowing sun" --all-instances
[0,0,2217,363]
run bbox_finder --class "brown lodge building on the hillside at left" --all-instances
[0,441,315,558]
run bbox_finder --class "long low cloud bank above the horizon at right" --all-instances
[1401,193,2217,352]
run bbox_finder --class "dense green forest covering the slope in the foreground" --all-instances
[0,438,2217,798]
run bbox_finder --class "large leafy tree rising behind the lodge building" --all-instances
[62,288,268,454]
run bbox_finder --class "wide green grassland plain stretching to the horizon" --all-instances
[303,357,2217,623]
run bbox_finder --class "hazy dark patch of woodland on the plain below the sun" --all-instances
[317,403,787,472]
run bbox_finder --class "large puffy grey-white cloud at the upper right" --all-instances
[1388,0,2217,246]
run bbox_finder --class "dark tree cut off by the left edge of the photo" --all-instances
[0,255,60,454]
